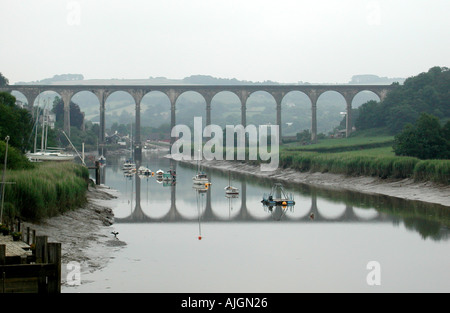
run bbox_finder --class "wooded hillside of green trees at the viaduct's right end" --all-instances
[355,67,450,159]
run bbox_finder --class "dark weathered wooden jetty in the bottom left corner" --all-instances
[0,221,61,294]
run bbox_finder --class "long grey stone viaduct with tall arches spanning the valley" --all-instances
[0,85,393,154]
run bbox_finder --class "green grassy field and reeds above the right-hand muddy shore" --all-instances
[280,137,450,185]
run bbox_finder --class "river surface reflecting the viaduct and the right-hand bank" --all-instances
[95,155,450,240]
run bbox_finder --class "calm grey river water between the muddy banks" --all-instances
[62,152,450,293]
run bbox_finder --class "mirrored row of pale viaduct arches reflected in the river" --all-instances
[116,169,386,223]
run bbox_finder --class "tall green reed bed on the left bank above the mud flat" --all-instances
[3,162,89,221]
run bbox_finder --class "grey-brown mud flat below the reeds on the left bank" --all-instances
[24,186,126,286]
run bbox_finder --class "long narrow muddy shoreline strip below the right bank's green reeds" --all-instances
[178,156,450,208]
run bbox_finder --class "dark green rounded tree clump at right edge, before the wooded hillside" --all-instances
[393,113,450,159]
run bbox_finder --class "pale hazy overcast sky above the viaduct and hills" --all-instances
[0,0,450,84]
